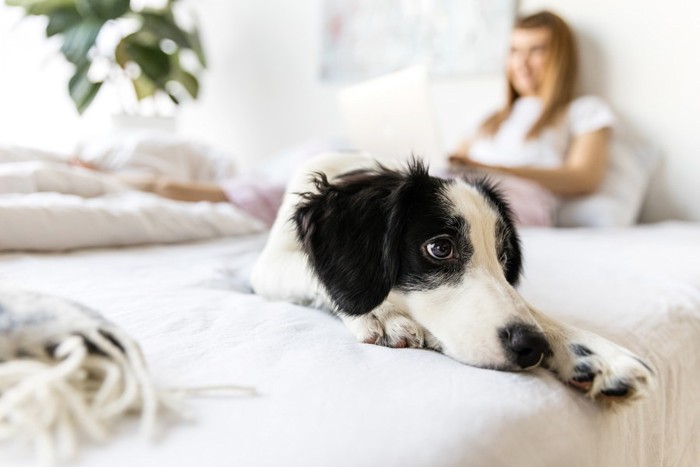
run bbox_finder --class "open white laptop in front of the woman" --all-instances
[338,66,447,169]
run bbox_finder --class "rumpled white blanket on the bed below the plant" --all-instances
[0,143,266,251]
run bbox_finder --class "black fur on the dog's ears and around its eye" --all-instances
[292,160,521,315]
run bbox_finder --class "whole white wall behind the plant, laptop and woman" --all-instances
[0,0,700,221]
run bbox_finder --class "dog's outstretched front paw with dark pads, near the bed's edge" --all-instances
[553,338,655,402]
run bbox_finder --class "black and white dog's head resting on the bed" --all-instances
[294,161,548,369]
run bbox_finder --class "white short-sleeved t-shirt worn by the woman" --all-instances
[469,96,616,168]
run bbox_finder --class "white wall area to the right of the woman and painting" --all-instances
[521,0,700,221]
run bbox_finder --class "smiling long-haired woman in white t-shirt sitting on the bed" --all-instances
[449,11,616,225]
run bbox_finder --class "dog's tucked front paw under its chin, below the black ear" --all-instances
[343,309,425,349]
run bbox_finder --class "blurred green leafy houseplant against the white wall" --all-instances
[5,0,206,115]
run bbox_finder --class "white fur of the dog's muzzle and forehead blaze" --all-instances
[404,181,539,369]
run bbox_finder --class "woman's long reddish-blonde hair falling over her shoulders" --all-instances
[480,11,578,139]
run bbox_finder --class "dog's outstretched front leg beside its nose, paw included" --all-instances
[530,307,654,401]
